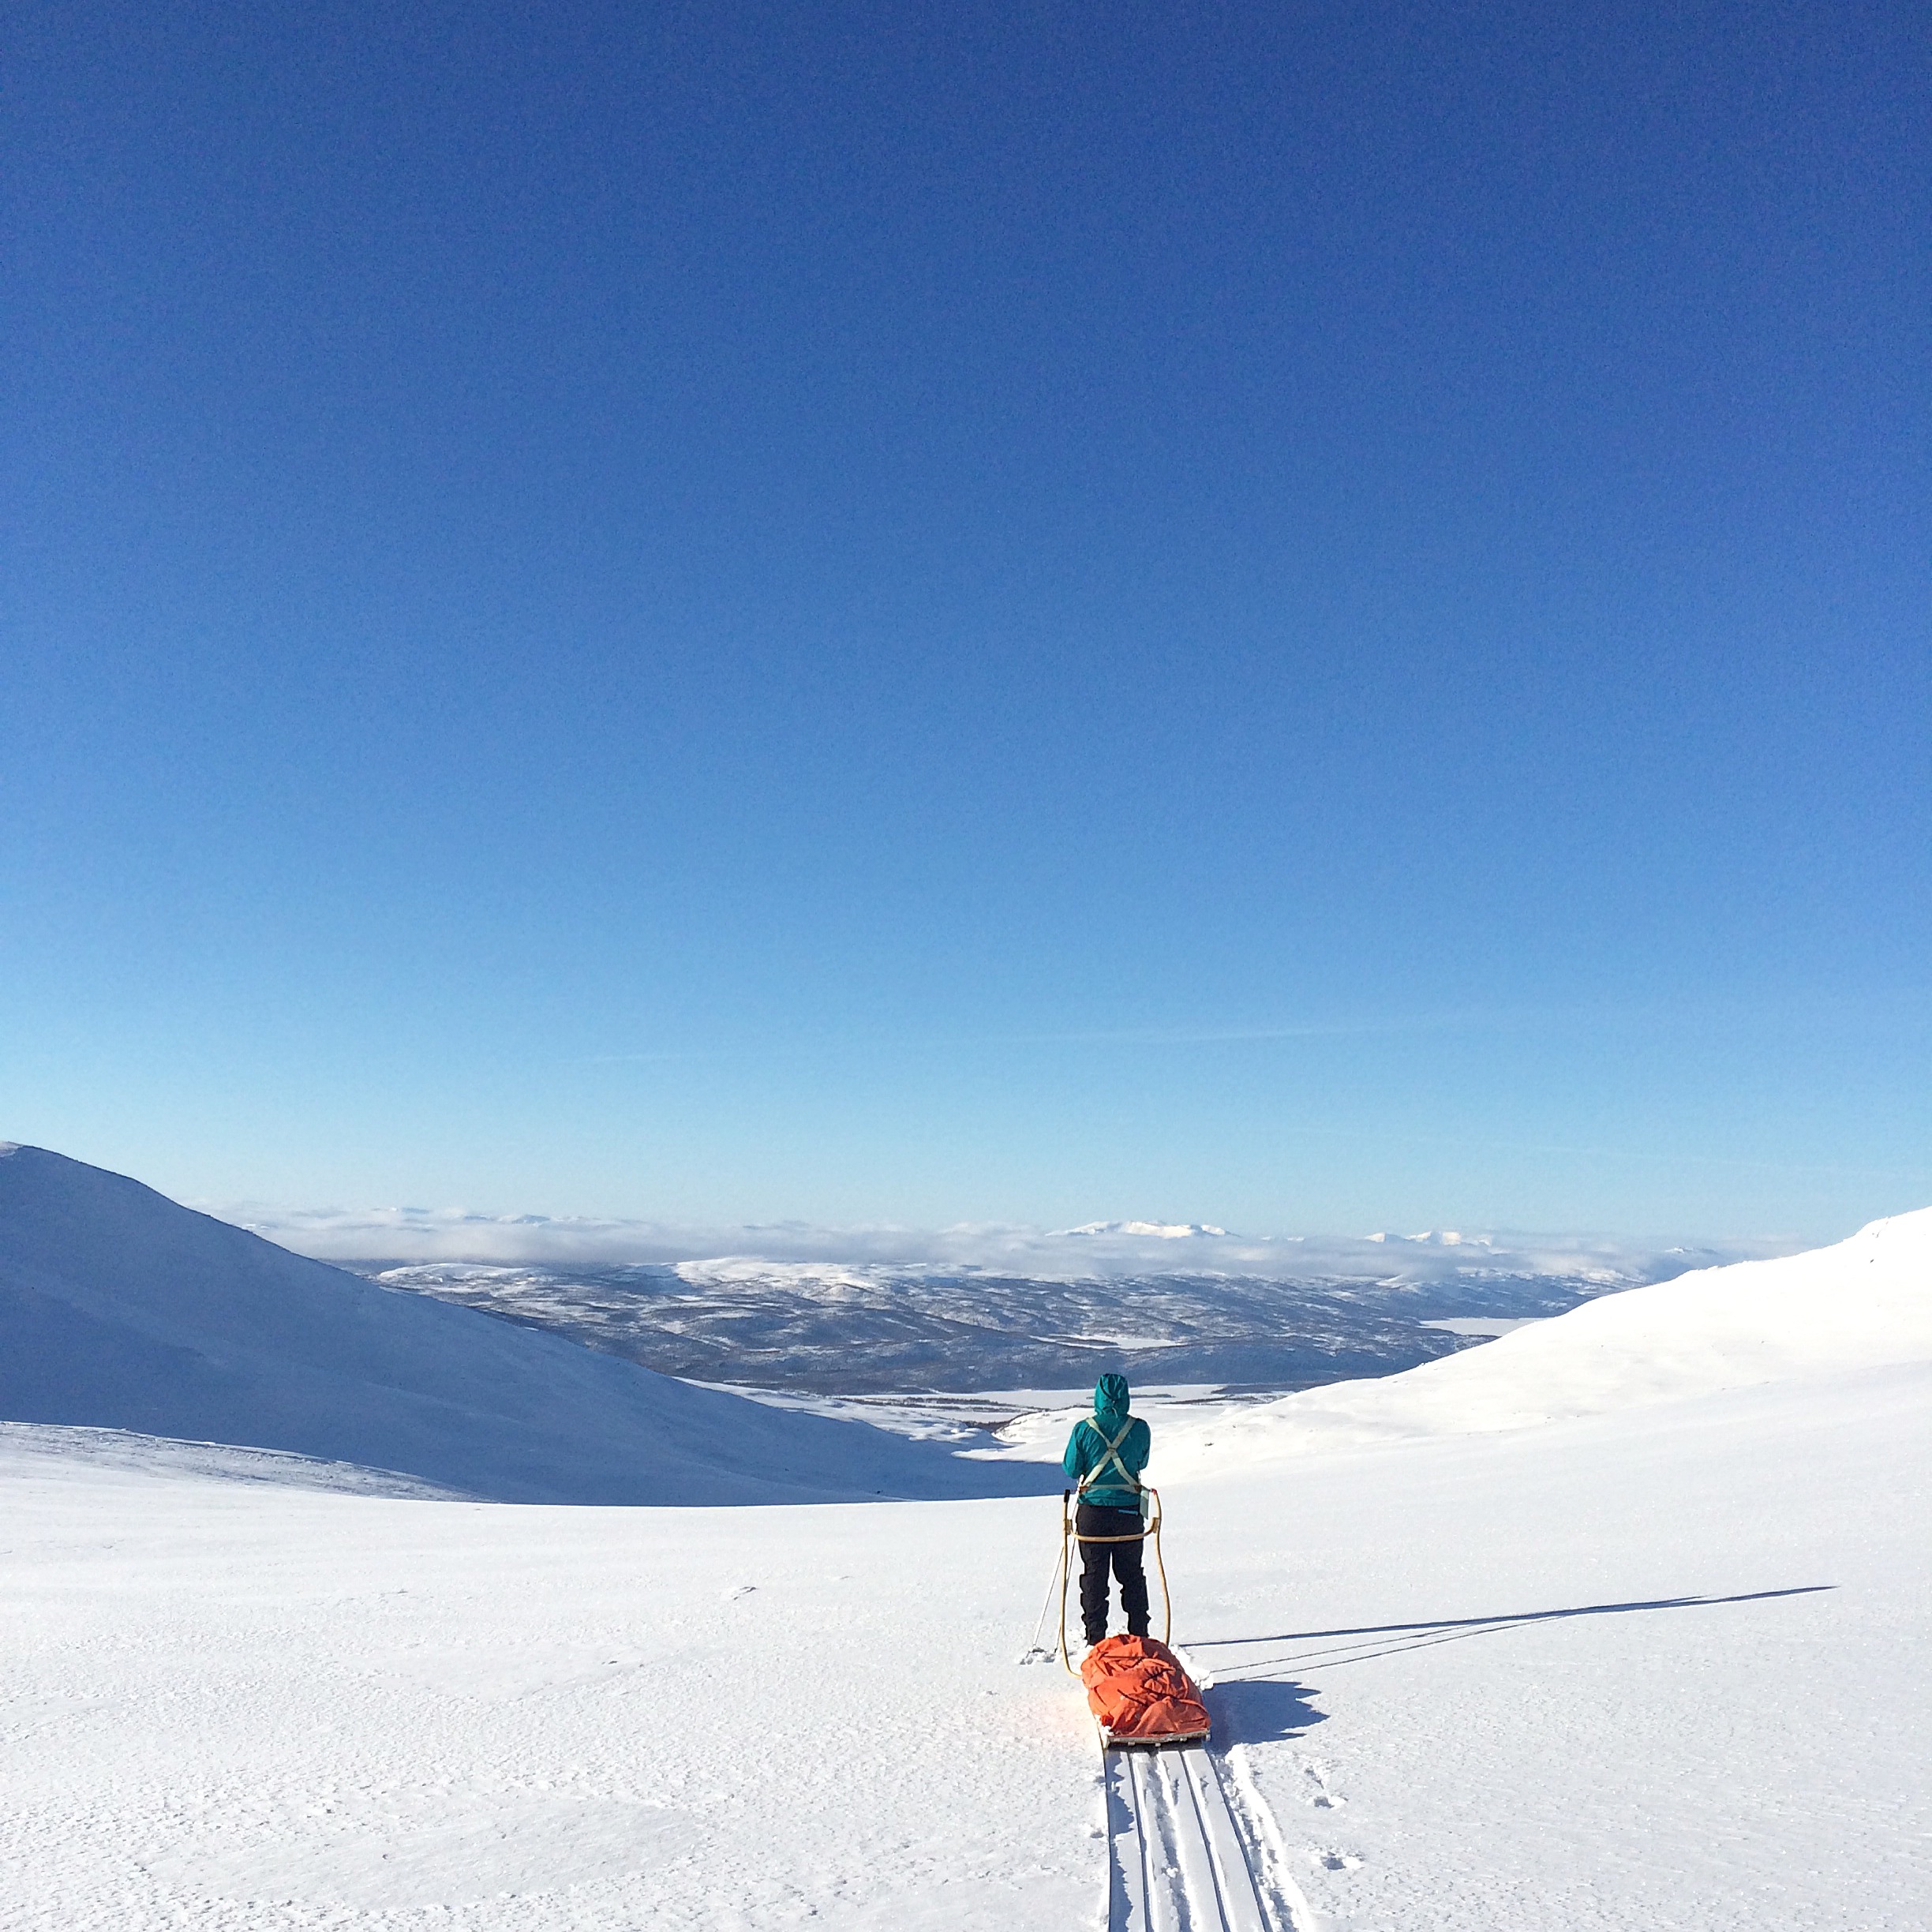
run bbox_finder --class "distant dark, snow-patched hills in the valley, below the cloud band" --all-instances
[328,1250,1723,1395]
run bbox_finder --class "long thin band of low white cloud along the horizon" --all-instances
[199,1202,1799,1286]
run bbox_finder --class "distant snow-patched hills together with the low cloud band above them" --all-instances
[224,1204,1789,1397]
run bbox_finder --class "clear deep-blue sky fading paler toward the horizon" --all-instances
[0,0,1932,1234]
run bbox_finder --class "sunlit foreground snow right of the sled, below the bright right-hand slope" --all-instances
[1169,1366,1932,1932]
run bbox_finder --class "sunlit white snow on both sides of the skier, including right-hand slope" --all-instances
[0,1161,1932,1932]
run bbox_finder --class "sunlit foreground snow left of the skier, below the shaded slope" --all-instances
[0,1465,1099,1932]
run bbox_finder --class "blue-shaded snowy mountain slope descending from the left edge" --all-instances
[0,1146,1045,1503]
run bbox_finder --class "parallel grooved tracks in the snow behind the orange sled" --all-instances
[1105,1743,1314,1932]
